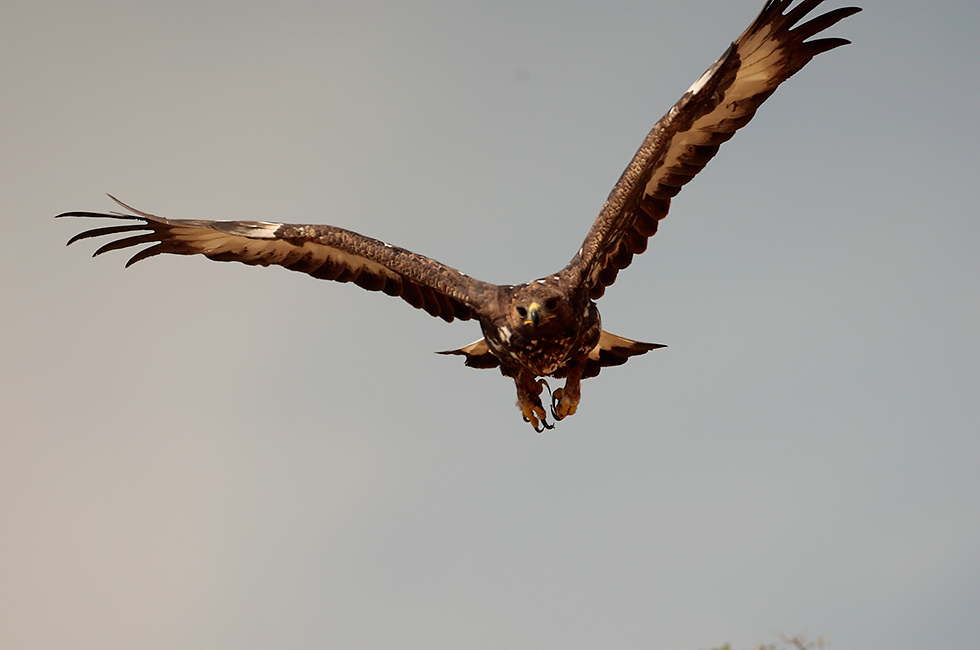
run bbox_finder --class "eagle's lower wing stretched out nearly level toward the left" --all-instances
[58,196,497,322]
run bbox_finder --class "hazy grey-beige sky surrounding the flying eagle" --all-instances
[0,0,980,650]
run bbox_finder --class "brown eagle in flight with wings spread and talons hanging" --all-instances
[58,0,861,433]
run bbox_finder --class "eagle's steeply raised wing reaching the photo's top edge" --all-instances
[565,0,861,299]
